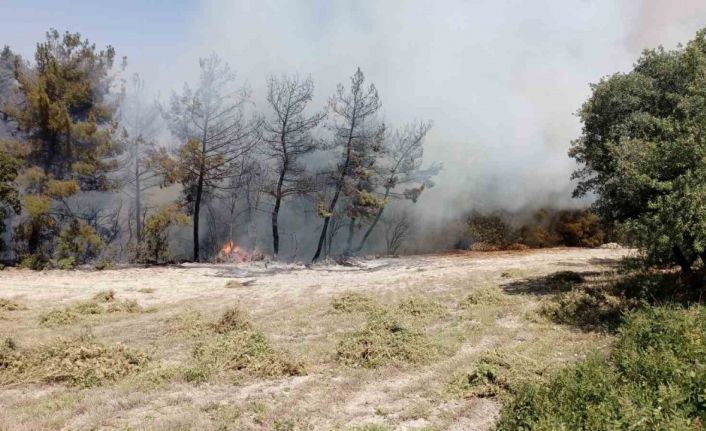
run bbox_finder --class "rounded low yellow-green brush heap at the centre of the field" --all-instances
[336,310,438,368]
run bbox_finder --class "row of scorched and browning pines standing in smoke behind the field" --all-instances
[0,30,440,268]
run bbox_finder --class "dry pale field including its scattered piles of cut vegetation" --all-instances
[0,248,629,430]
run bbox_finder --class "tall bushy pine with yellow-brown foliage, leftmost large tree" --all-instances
[6,30,121,260]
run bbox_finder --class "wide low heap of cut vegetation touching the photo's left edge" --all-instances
[0,336,149,387]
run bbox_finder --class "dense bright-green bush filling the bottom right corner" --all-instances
[497,307,706,430]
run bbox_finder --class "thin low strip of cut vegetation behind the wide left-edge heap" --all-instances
[39,290,149,327]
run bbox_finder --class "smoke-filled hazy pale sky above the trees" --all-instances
[0,0,706,223]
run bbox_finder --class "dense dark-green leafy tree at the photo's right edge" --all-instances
[570,30,706,272]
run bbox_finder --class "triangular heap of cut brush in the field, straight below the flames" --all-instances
[186,307,305,382]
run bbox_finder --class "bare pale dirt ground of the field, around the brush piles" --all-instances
[0,248,629,431]
